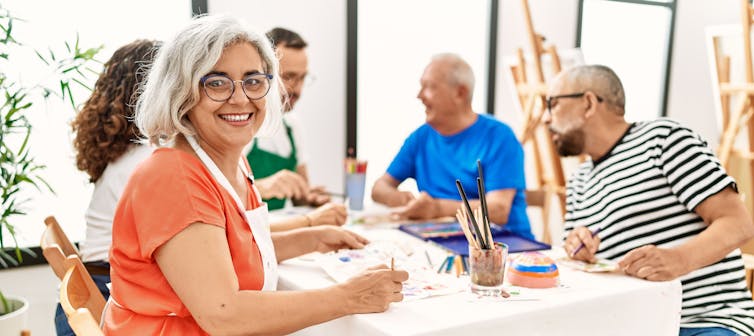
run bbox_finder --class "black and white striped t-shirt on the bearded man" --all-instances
[565,119,754,336]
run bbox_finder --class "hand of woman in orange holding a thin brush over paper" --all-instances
[338,265,408,314]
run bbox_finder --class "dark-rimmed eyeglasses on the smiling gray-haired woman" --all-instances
[200,73,272,102]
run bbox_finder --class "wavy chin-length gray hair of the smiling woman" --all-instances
[136,15,281,146]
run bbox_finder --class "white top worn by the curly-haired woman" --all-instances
[79,145,154,262]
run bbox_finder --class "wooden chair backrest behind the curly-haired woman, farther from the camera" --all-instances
[39,216,79,280]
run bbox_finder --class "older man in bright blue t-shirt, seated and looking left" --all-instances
[372,54,533,238]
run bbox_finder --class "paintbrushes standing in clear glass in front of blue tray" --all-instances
[456,160,495,250]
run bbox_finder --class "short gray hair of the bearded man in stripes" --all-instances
[563,65,626,114]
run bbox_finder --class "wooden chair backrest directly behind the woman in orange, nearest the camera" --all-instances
[60,256,105,335]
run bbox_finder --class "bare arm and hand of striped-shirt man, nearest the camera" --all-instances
[620,187,754,281]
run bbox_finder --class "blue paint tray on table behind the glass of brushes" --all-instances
[398,222,550,256]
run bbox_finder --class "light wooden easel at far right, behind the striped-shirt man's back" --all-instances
[713,0,754,290]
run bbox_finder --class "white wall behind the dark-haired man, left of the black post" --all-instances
[208,0,346,192]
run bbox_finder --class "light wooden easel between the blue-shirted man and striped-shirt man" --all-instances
[509,0,565,244]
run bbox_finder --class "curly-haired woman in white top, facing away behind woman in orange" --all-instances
[55,40,160,335]
